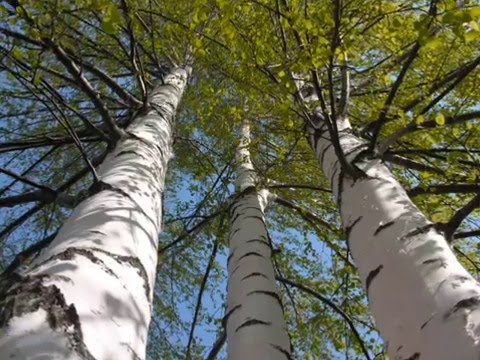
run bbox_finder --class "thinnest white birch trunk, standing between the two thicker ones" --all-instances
[225,122,291,360]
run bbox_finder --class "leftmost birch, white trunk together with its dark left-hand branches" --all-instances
[0,2,195,359]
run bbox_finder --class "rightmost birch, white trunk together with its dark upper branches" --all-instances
[300,2,479,359]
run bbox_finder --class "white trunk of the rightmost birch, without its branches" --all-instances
[309,115,480,360]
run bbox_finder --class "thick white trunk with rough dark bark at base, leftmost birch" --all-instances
[0,69,188,360]
